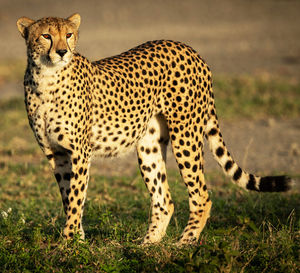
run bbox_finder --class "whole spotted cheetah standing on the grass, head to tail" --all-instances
[17,13,291,245]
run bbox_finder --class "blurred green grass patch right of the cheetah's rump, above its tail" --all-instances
[214,76,300,119]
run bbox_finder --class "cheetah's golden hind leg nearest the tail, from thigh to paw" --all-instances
[171,127,212,242]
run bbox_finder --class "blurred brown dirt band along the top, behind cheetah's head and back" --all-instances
[0,0,300,77]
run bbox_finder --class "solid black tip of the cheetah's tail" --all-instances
[259,175,293,192]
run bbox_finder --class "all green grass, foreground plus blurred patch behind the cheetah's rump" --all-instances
[0,73,300,272]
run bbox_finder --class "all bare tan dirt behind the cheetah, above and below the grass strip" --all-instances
[0,0,300,175]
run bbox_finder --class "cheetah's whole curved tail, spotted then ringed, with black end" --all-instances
[205,110,292,192]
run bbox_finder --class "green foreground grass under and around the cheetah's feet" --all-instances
[0,162,300,272]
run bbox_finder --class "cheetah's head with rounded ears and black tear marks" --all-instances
[17,13,80,68]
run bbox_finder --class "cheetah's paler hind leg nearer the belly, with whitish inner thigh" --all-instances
[137,113,174,244]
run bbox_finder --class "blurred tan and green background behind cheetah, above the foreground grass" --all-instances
[0,0,300,174]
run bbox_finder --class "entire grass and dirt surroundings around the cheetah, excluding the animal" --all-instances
[0,0,300,272]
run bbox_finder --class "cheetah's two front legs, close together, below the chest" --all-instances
[47,150,90,239]
